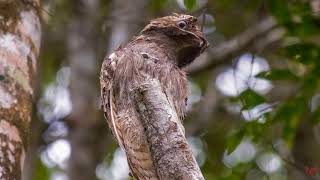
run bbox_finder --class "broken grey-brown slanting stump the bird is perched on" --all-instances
[136,79,204,180]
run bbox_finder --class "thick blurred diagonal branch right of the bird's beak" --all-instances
[185,17,277,73]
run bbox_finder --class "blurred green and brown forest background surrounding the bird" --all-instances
[23,0,320,180]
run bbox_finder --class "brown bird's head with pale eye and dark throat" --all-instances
[141,13,209,67]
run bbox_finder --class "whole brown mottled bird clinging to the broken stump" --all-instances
[100,14,208,180]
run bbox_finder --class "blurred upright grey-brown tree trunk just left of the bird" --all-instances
[67,0,108,180]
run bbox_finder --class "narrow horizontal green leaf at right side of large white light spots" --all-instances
[256,69,299,81]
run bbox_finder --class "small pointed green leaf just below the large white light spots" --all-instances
[235,89,266,109]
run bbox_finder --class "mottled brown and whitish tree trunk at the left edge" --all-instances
[0,0,41,179]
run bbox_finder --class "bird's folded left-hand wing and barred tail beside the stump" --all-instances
[100,51,158,180]
